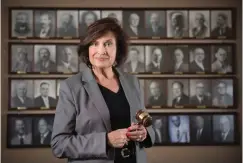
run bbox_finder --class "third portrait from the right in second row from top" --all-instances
[166,45,189,73]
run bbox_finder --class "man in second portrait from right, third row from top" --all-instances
[190,81,211,106]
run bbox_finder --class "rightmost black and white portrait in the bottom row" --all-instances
[213,114,235,143]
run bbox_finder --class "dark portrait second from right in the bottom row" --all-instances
[190,115,212,144]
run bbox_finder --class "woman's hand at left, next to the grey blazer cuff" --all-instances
[107,128,129,148]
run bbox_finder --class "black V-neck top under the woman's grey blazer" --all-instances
[98,80,136,163]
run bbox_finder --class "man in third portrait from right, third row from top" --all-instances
[172,81,189,106]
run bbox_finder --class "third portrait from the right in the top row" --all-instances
[166,10,188,38]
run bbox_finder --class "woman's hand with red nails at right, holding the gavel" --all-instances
[127,123,147,142]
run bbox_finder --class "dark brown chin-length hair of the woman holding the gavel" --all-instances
[78,17,128,68]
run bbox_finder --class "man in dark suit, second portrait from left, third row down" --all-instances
[35,81,56,108]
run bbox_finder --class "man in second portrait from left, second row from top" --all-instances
[35,47,56,72]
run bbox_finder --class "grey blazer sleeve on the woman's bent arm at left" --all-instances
[51,81,114,159]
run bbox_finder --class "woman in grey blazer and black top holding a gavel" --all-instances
[51,18,155,163]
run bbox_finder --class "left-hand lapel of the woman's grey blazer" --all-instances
[82,68,111,131]
